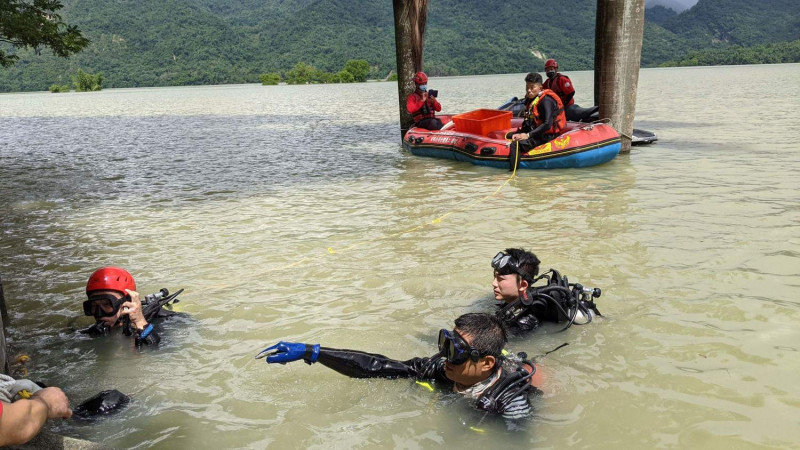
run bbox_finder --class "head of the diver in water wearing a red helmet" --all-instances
[83,266,136,327]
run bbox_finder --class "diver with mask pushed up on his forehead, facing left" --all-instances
[492,248,601,334]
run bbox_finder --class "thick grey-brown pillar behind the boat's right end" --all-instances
[594,0,645,153]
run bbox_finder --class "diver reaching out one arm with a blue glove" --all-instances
[256,313,538,419]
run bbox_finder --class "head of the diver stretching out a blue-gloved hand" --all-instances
[439,313,507,387]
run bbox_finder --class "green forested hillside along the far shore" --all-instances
[0,0,800,91]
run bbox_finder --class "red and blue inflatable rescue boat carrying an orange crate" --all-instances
[403,109,621,169]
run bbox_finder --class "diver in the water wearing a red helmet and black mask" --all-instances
[80,266,183,347]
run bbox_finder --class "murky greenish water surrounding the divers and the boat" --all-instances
[0,65,800,448]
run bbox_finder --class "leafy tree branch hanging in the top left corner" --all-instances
[0,0,89,67]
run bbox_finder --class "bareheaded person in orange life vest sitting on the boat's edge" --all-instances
[506,73,567,153]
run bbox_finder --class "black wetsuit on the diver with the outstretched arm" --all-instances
[317,347,536,419]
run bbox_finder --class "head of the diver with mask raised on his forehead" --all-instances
[492,248,541,303]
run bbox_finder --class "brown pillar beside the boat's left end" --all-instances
[392,0,428,138]
